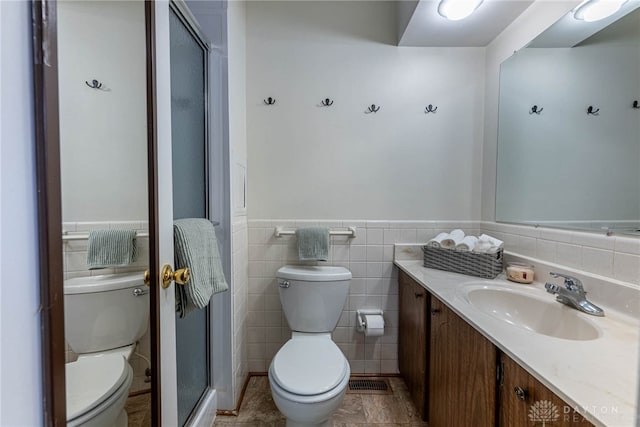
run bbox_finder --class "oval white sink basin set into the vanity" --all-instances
[458,282,601,341]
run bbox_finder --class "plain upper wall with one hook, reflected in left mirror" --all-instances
[58,1,148,222]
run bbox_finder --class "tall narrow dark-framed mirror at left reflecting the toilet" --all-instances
[57,0,151,426]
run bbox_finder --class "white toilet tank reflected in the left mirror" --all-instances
[64,272,149,354]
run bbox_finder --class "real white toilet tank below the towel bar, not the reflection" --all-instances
[276,265,351,332]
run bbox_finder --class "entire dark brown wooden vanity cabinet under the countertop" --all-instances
[398,270,592,427]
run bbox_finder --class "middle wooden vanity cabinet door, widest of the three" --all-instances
[429,295,497,427]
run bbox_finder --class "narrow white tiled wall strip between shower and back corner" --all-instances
[231,221,249,402]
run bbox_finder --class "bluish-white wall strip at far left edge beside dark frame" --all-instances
[0,1,43,426]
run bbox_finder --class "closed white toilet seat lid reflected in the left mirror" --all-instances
[65,354,133,425]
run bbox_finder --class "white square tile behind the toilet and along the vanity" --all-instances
[247,220,640,374]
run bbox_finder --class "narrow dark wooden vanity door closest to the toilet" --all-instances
[398,271,429,419]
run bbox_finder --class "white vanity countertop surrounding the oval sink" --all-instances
[394,259,640,427]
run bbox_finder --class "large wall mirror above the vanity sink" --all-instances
[496,2,640,235]
